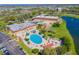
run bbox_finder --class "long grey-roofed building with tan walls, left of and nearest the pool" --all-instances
[7,21,36,36]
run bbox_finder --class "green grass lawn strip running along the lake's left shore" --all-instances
[52,21,76,54]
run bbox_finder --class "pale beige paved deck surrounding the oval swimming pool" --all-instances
[16,30,61,50]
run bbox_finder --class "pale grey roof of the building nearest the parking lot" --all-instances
[8,21,35,31]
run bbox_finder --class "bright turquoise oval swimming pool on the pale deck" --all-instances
[29,34,42,44]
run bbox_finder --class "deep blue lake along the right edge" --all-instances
[62,16,79,54]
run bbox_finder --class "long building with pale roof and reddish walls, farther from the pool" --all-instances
[32,15,61,25]
